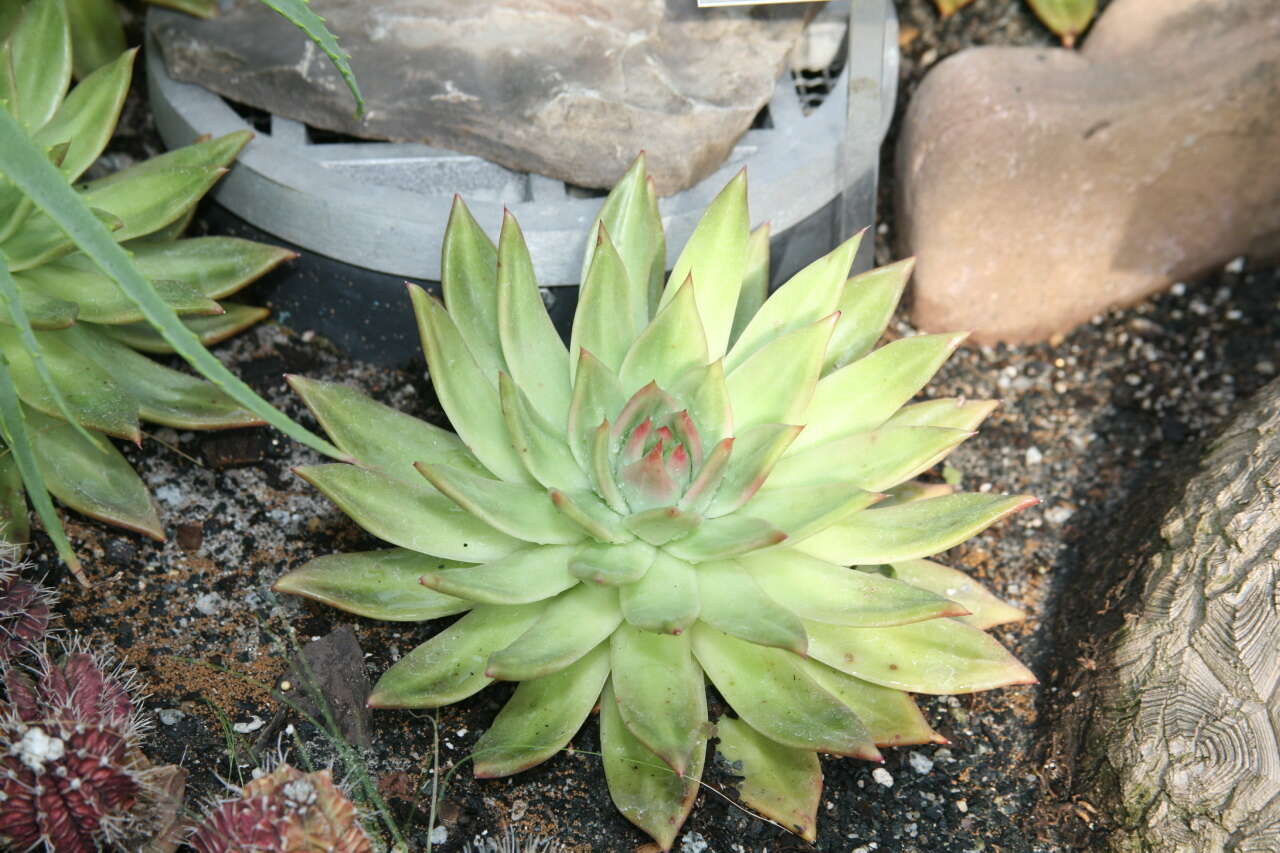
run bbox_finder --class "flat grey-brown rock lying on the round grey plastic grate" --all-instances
[154,0,808,195]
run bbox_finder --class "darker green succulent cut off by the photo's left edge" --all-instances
[0,0,292,568]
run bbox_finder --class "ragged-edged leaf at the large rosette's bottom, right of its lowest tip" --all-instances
[716,717,822,841]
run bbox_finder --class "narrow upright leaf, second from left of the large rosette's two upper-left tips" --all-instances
[498,211,571,424]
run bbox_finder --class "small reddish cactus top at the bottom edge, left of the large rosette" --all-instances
[188,765,372,853]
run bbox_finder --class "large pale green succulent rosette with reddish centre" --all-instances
[276,159,1034,848]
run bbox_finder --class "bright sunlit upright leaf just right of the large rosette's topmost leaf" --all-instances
[660,169,750,358]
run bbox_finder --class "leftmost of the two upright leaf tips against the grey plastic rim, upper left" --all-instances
[440,196,507,379]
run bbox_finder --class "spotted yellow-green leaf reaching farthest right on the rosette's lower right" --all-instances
[805,619,1036,694]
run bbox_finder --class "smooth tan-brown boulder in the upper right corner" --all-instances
[897,0,1280,343]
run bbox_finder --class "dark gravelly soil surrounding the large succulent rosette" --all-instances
[20,0,1280,853]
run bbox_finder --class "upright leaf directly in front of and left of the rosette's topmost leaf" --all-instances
[568,224,649,379]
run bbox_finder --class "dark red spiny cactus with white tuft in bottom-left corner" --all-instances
[0,647,148,853]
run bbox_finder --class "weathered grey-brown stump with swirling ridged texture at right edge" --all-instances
[1069,382,1280,853]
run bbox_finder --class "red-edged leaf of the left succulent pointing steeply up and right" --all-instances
[31,47,138,181]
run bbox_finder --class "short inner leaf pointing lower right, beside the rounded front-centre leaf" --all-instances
[698,560,809,656]
